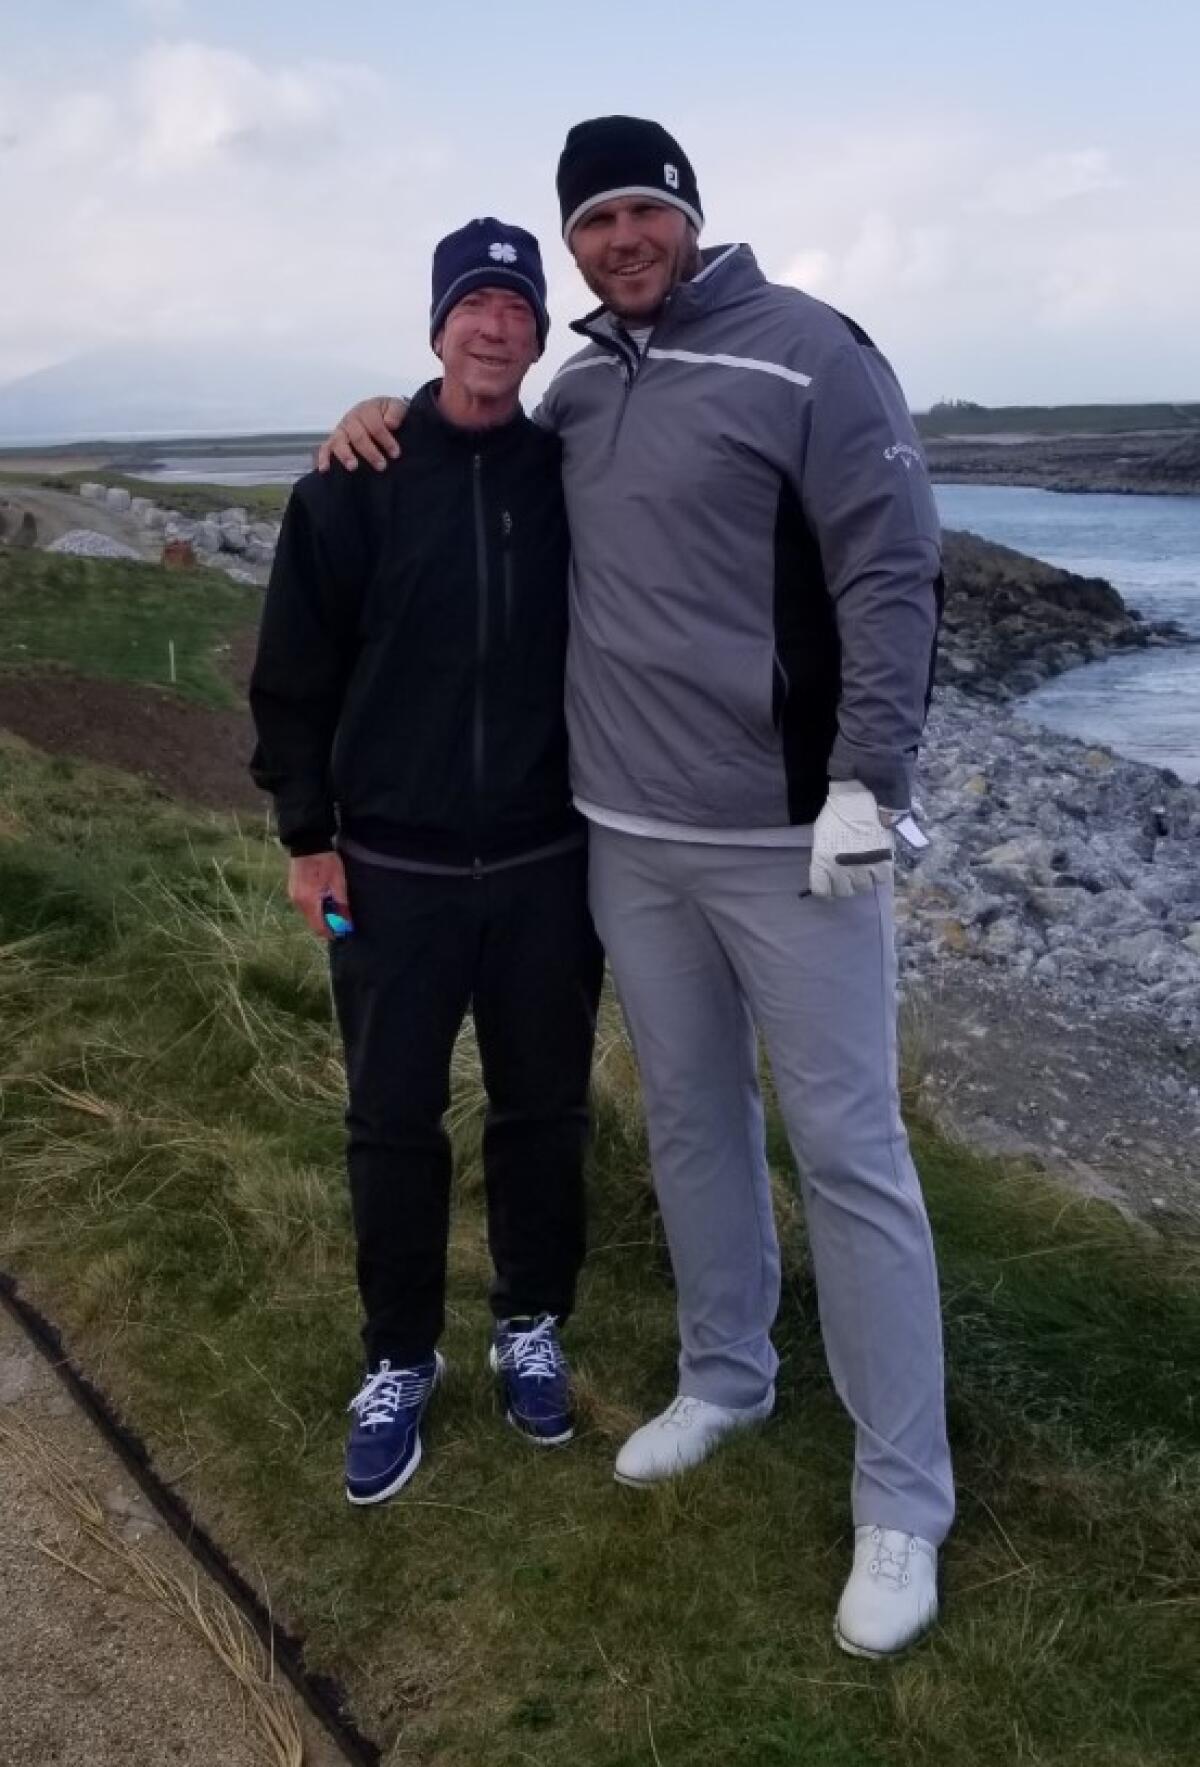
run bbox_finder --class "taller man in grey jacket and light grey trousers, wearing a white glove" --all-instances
[321,117,953,1656]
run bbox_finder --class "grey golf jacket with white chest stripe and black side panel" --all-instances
[535,246,942,829]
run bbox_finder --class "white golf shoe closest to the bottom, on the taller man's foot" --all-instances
[834,1525,937,1657]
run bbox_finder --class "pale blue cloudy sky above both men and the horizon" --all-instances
[0,0,1200,419]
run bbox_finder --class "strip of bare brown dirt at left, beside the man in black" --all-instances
[0,670,267,811]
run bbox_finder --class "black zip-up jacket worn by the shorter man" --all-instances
[249,383,581,869]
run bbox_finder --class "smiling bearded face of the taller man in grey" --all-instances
[567,196,700,325]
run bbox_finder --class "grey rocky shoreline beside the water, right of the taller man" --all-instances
[896,534,1200,1232]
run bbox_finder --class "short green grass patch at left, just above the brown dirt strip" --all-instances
[0,550,262,705]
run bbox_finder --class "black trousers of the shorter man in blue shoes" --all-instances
[330,848,603,1366]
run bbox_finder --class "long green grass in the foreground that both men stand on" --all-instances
[0,739,1200,1767]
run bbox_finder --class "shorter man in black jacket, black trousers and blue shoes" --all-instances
[251,219,603,1504]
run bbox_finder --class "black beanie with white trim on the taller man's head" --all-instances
[558,117,703,244]
